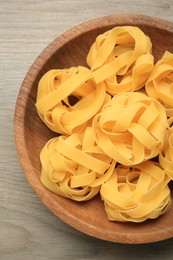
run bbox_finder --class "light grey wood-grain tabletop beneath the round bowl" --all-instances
[0,0,173,260]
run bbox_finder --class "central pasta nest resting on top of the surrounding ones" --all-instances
[93,92,168,165]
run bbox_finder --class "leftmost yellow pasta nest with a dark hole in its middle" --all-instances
[36,66,110,134]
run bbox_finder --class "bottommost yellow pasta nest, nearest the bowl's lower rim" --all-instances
[100,161,171,222]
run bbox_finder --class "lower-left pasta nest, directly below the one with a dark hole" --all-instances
[40,127,115,201]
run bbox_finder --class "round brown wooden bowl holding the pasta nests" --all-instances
[14,14,173,243]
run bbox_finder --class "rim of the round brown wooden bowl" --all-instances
[14,14,173,244]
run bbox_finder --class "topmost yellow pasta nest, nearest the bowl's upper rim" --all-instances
[87,26,154,95]
